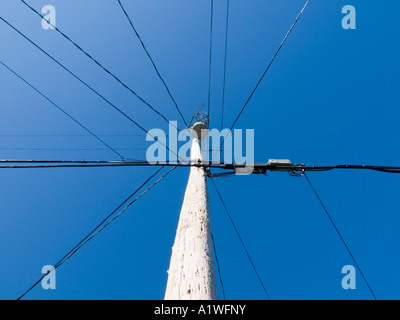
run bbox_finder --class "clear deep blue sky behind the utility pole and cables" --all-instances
[0,0,400,299]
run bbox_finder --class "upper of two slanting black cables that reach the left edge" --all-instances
[0,16,180,158]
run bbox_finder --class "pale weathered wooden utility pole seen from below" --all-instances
[165,125,218,300]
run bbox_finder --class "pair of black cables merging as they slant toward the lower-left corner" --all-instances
[17,167,176,300]
